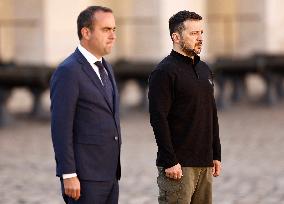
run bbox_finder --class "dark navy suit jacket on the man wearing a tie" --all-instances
[50,49,121,181]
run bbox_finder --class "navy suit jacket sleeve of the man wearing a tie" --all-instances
[50,67,79,176]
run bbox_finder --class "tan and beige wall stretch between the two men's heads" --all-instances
[113,0,160,61]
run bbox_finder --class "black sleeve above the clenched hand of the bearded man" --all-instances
[148,70,178,168]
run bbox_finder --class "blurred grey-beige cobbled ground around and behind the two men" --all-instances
[0,101,284,204]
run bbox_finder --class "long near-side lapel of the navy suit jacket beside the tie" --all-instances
[75,48,113,112]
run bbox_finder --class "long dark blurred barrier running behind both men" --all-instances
[0,54,284,126]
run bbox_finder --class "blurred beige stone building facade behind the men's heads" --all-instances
[0,0,284,65]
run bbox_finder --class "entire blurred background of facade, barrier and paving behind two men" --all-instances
[0,0,284,204]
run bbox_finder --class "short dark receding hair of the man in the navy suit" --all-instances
[77,6,112,40]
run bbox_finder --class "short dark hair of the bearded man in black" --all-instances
[169,10,202,38]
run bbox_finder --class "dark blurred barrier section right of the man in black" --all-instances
[212,54,284,108]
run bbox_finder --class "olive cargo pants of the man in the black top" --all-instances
[157,167,212,204]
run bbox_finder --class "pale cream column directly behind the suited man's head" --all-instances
[43,0,92,65]
